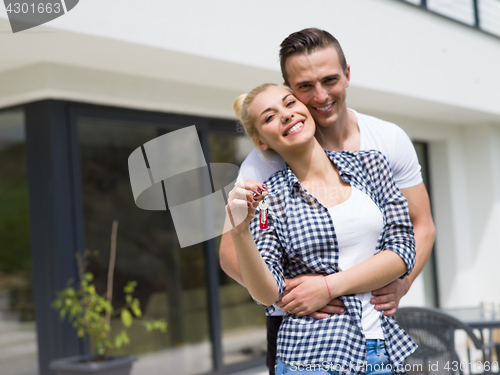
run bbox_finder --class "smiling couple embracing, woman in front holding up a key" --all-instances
[220,29,434,374]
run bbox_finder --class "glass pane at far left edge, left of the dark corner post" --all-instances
[0,109,38,375]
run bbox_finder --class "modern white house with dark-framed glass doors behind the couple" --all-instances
[0,0,500,375]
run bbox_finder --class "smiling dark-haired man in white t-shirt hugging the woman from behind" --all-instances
[220,28,435,374]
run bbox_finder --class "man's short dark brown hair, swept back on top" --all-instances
[280,28,347,85]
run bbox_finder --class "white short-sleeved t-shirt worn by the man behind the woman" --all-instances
[236,108,423,315]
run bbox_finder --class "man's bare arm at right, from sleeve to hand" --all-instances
[370,182,436,316]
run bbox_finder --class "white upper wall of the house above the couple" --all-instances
[0,0,500,116]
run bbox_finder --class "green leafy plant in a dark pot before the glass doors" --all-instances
[49,220,167,375]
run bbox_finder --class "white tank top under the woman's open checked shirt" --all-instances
[328,186,384,339]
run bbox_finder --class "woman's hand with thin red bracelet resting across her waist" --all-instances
[279,275,337,316]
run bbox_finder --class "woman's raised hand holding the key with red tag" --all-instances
[226,180,269,234]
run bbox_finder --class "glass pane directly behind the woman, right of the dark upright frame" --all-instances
[209,133,266,365]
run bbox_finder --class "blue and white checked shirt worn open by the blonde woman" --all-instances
[250,151,417,375]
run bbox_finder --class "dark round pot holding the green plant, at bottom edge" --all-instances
[49,355,137,375]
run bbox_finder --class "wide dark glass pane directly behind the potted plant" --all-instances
[78,118,213,375]
